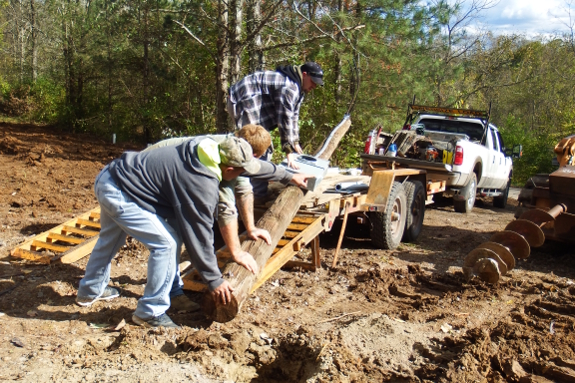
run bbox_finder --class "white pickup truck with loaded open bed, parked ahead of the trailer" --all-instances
[362,104,521,213]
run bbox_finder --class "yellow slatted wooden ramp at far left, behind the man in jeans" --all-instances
[10,207,100,264]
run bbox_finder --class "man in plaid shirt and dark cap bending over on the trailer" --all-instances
[228,62,323,198]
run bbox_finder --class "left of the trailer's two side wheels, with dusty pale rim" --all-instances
[369,182,407,250]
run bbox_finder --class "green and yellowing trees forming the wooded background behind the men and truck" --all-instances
[0,0,575,184]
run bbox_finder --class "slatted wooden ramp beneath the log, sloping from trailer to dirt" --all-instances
[182,212,331,293]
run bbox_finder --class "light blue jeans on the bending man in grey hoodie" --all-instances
[78,167,181,320]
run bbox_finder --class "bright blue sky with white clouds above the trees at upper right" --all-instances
[467,0,575,37]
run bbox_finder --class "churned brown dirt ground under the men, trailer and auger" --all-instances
[0,124,575,382]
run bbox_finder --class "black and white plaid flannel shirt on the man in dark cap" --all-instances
[229,71,304,147]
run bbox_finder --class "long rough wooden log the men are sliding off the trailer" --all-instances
[202,116,351,323]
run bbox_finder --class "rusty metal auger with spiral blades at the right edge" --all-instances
[463,136,575,283]
